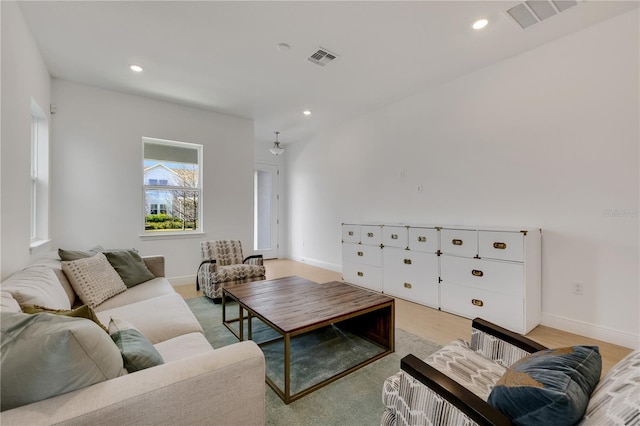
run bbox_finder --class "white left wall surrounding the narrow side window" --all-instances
[0,1,51,279]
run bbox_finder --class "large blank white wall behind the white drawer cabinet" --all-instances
[287,10,640,346]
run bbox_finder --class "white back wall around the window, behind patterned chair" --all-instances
[51,79,254,284]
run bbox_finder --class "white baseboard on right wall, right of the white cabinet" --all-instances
[541,312,640,349]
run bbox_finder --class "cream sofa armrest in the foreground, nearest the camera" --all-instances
[0,341,265,425]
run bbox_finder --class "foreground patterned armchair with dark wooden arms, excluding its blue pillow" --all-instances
[381,318,640,426]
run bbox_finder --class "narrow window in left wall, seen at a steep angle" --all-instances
[29,99,49,248]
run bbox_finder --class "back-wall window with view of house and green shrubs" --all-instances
[142,138,202,235]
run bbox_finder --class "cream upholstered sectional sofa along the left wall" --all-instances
[0,251,265,425]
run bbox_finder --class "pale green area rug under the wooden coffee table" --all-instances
[187,297,440,426]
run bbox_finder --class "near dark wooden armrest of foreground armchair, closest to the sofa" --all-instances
[399,354,511,426]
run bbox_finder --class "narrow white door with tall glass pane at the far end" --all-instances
[253,164,279,259]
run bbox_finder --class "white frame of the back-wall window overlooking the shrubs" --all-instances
[140,137,204,238]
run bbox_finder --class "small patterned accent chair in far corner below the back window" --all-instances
[196,240,266,303]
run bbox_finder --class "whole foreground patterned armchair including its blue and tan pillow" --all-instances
[381,318,640,426]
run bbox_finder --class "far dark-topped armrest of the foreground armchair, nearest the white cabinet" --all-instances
[469,318,547,367]
